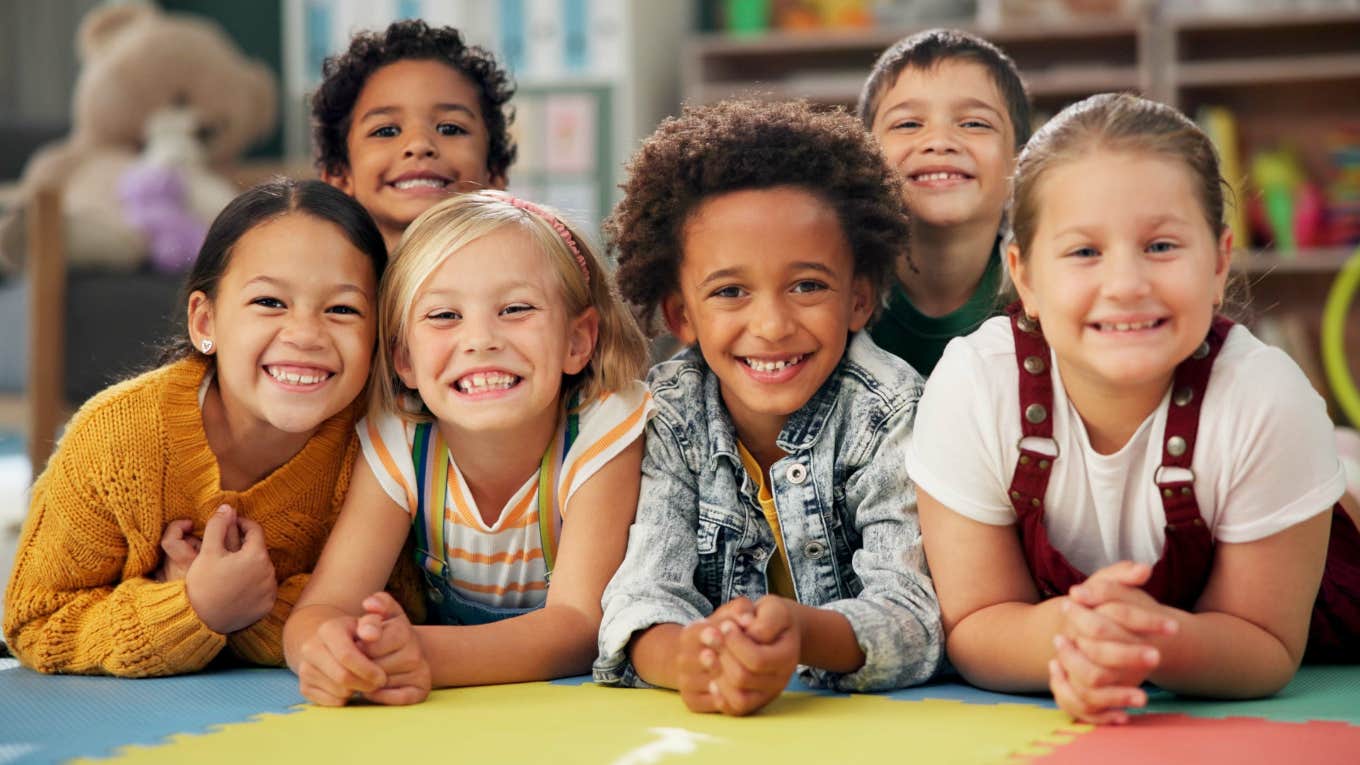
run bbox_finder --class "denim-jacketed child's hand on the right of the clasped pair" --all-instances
[709,595,801,716]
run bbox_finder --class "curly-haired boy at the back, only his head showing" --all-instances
[311,19,515,252]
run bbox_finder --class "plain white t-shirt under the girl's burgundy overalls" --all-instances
[907,317,1345,573]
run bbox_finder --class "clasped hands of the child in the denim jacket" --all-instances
[676,595,801,716]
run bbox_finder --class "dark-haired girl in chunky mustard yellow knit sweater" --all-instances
[4,180,386,677]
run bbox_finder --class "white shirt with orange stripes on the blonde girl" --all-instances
[356,381,653,608]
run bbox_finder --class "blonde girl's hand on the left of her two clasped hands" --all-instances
[296,615,388,706]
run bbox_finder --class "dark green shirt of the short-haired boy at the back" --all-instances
[869,240,1005,377]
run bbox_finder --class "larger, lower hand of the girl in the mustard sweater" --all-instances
[185,505,279,634]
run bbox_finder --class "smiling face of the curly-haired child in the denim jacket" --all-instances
[664,186,873,448]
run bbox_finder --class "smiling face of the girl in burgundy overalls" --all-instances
[1006,148,1231,411]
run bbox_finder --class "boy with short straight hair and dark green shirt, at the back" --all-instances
[858,29,1030,377]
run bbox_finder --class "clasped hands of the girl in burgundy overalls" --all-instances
[1049,561,1179,724]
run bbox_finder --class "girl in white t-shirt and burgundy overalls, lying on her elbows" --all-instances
[907,94,1360,723]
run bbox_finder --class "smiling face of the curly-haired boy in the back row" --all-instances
[324,59,505,249]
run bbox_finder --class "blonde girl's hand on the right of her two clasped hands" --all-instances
[355,592,431,705]
